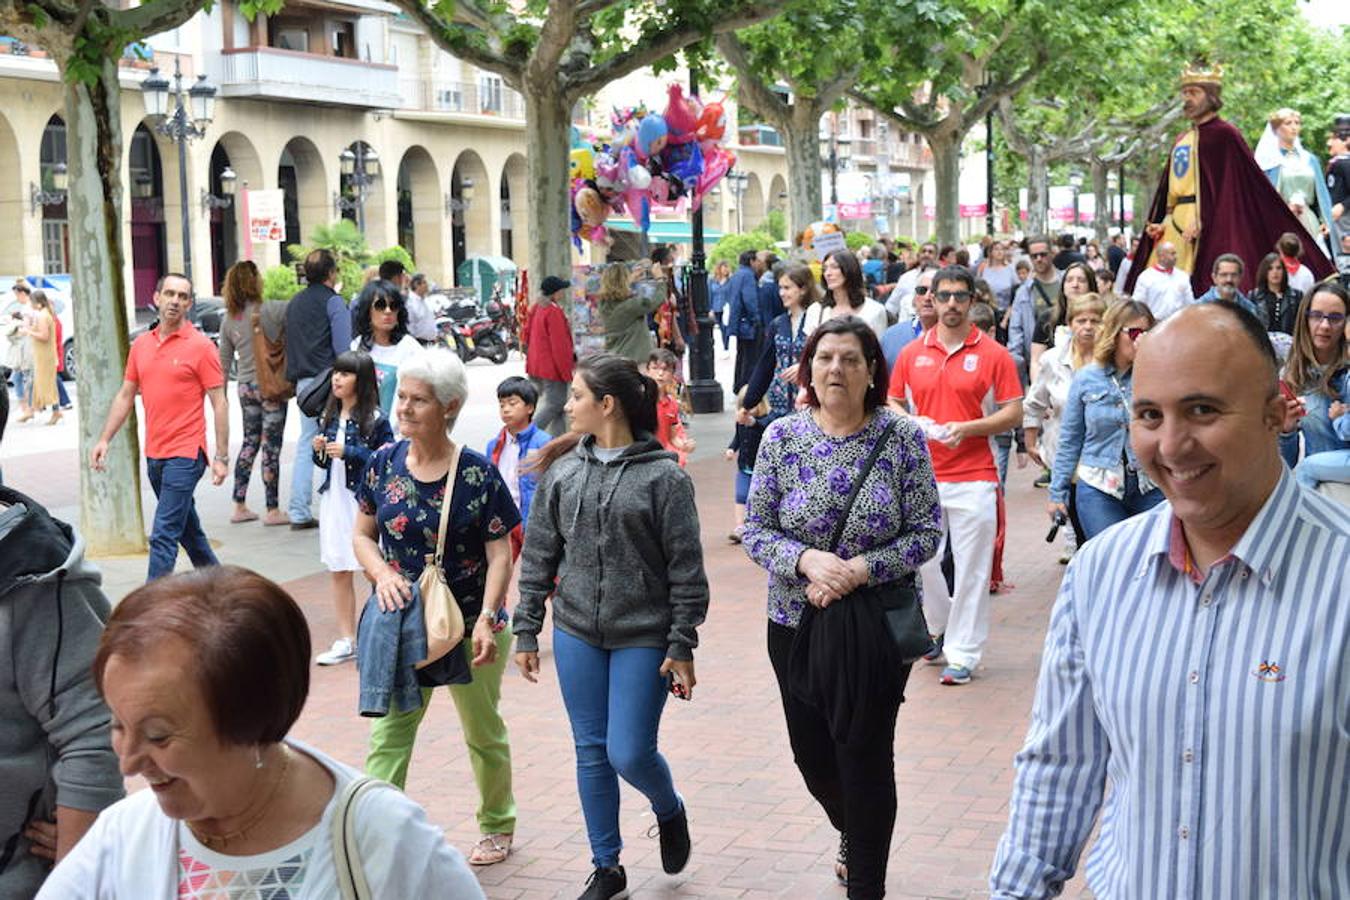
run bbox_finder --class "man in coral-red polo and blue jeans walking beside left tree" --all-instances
[89,274,230,580]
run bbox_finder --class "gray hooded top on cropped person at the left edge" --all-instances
[0,488,123,900]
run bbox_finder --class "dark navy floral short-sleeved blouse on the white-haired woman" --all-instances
[356,440,520,621]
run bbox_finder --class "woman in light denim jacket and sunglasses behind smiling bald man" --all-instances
[1049,300,1162,540]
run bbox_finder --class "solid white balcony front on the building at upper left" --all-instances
[213,47,400,109]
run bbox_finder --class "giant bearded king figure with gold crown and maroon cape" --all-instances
[1125,66,1334,296]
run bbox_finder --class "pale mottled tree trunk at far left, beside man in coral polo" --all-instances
[65,61,146,556]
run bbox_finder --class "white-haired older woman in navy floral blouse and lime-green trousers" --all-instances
[354,351,520,865]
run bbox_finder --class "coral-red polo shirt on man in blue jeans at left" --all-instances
[126,321,225,459]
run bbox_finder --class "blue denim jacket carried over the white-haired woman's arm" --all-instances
[356,583,474,718]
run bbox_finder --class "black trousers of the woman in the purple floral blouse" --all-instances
[768,622,909,900]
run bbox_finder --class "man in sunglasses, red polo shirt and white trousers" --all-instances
[888,266,1022,684]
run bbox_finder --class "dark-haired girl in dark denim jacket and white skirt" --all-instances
[313,351,394,665]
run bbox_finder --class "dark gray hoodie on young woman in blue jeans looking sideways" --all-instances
[513,433,707,660]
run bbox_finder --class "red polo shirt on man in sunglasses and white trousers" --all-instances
[888,325,1022,482]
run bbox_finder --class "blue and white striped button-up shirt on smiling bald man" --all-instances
[991,472,1350,900]
